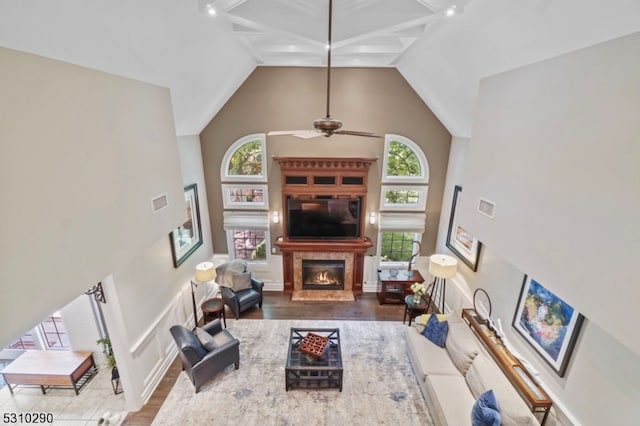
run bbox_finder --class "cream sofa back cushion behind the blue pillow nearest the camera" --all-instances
[466,353,539,425]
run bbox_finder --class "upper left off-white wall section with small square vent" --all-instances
[0,48,184,347]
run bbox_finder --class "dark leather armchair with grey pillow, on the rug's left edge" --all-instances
[169,319,240,393]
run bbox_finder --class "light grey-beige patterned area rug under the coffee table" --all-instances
[152,319,433,426]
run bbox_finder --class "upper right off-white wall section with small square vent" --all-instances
[461,33,640,354]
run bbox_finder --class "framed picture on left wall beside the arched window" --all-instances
[169,183,202,268]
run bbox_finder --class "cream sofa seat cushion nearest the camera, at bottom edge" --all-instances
[425,374,476,426]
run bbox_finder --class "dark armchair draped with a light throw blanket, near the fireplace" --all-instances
[216,260,264,319]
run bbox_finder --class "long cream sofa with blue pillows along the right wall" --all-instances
[405,314,540,426]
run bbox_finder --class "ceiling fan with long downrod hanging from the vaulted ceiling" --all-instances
[268,0,382,139]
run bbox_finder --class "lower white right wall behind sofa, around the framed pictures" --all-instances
[437,138,640,425]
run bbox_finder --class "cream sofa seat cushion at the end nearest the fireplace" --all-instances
[405,327,461,382]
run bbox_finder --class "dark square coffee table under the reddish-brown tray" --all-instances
[284,328,343,392]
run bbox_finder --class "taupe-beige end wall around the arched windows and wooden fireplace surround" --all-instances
[200,67,451,255]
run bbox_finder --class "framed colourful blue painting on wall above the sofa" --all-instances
[513,275,584,377]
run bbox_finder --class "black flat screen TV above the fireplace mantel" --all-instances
[287,198,360,240]
